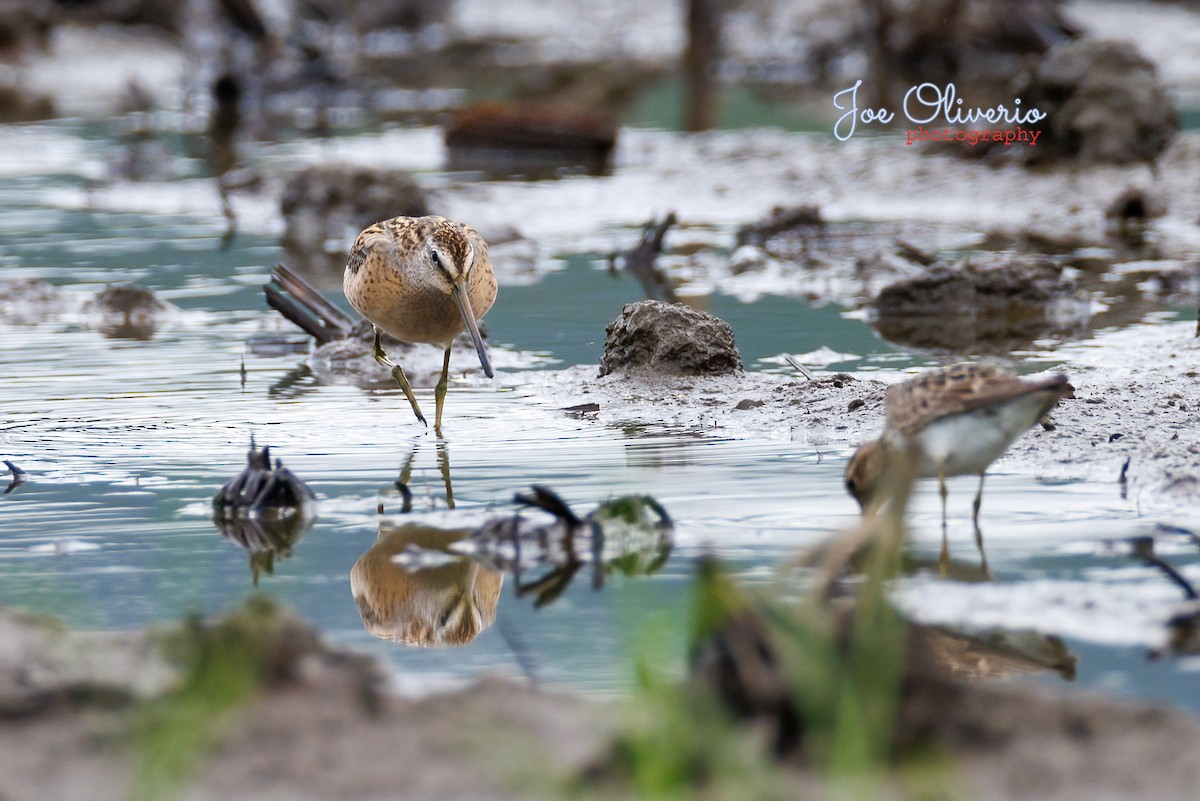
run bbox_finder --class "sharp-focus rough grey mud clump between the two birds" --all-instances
[600,301,743,375]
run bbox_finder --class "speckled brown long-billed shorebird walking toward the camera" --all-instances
[342,217,496,435]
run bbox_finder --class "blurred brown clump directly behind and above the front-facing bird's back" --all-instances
[280,165,430,275]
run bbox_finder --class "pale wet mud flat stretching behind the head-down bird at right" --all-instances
[528,323,1200,512]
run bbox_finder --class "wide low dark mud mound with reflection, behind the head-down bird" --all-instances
[872,254,1088,353]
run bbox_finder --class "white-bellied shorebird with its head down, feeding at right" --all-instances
[845,363,1069,563]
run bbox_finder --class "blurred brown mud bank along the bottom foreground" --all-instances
[0,599,1200,801]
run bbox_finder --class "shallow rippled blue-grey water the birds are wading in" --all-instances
[0,121,1200,710]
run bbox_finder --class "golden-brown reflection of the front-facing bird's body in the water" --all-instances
[350,524,504,645]
